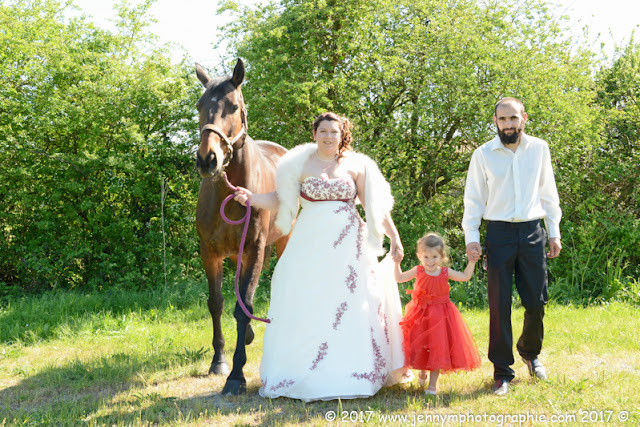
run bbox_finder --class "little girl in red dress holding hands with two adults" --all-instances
[394,233,480,395]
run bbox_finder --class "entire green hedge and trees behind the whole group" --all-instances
[0,0,640,306]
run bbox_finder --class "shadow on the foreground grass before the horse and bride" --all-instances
[0,353,496,426]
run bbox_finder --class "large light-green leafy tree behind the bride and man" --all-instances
[216,0,598,244]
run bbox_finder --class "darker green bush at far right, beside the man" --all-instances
[552,39,640,303]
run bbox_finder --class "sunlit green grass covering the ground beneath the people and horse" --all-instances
[0,284,640,426]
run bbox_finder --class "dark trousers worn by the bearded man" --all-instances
[485,220,548,381]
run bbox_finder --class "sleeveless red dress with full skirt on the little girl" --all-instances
[400,265,480,372]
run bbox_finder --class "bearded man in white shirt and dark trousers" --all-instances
[462,98,562,395]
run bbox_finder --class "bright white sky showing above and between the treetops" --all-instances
[74,0,640,67]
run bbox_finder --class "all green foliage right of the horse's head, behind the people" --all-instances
[216,0,640,305]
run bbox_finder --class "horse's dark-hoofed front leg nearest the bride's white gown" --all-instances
[222,239,265,395]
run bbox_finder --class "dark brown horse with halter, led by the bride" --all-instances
[196,59,288,395]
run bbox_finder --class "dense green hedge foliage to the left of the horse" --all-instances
[0,0,200,290]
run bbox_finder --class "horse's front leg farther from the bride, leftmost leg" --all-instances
[200,244,230,375]
